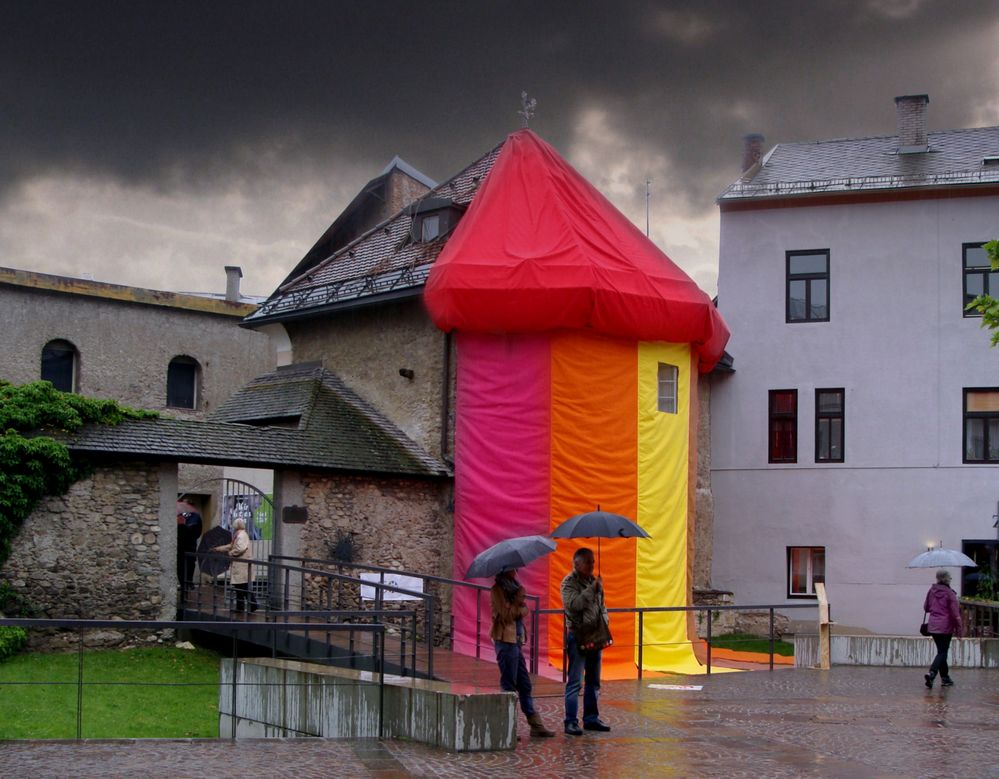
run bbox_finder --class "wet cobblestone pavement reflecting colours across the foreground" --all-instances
[0,667,999,779]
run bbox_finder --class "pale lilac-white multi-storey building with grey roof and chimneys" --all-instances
[711,95,999,634]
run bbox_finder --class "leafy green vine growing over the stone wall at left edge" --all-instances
[0,379,158,566]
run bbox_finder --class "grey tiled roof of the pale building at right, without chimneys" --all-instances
[718,127,999,203]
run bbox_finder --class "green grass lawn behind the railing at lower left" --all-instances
[0,646,219,739]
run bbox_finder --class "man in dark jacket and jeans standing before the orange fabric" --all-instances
[562,549,610,736]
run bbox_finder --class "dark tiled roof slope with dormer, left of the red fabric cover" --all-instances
[244,144,502,326]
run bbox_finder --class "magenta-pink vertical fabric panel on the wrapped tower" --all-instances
[454,333,551,658]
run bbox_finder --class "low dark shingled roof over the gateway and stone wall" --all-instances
[64,364,451,477]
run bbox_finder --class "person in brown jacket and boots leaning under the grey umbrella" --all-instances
[489,570,555,738]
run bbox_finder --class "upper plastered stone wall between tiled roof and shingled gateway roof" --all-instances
[286,300,454,456]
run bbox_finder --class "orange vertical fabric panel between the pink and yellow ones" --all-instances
[549,331,638,678]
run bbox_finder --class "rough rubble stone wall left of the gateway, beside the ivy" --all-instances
[0,463,177,646]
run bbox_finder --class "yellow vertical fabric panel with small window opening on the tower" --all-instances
[635,341,701,673]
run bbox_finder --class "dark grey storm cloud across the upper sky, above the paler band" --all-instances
[0,0,999,207]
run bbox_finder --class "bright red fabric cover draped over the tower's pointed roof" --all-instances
[424,130,729,372]
